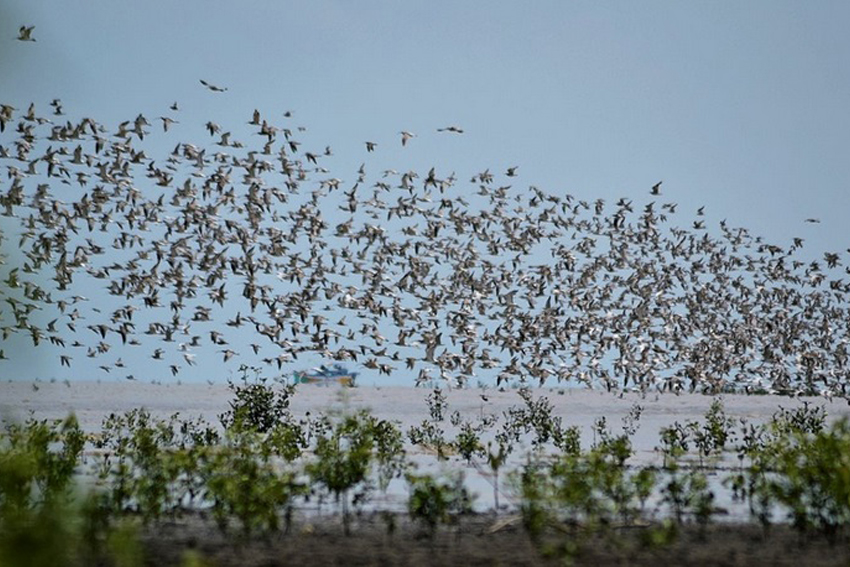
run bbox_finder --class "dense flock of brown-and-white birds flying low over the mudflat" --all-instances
[0,27,850,398]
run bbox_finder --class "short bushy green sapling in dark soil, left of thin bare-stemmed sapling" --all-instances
[407,473,473,538]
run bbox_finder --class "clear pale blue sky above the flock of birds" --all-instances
[0,0,850,386]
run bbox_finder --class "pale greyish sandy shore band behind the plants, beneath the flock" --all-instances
[0,381,850,451]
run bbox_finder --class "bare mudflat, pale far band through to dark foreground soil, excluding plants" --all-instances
[0,381,850,567]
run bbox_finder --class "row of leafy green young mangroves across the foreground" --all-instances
[0,378,850,565]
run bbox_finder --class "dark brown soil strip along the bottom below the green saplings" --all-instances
[131,514,850,567]
